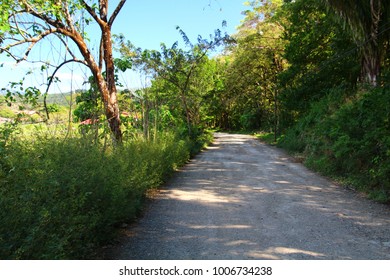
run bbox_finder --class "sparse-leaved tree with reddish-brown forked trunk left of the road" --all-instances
[0,0,126,142]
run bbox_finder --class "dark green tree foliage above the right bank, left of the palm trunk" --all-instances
[279,0,360,114]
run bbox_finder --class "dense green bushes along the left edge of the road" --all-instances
[0,131,195,259]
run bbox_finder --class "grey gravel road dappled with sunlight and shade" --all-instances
[109,133,390,260]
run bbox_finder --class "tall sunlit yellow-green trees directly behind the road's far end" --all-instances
[206,1,285,130]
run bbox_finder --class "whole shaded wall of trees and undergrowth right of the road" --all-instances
[251,0,390,203]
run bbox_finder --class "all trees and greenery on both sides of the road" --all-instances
[0,0,390,259]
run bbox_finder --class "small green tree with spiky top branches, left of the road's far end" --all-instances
[117,23,230,136]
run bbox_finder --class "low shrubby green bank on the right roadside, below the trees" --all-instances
[279,85,390,202]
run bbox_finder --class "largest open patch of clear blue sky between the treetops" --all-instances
[113,0,245,48]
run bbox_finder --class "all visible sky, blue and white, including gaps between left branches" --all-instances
[0,0,247,92]
